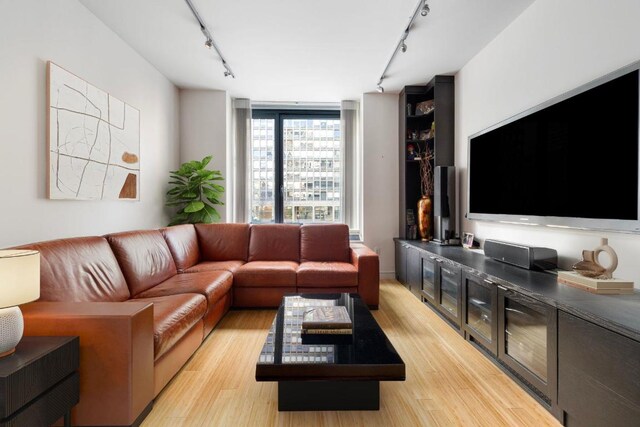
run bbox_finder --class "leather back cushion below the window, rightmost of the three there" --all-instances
[300,224,351,262]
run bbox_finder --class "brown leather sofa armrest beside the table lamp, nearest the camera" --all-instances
[20,302,154,425]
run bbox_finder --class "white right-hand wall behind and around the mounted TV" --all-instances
[456,0,640,287]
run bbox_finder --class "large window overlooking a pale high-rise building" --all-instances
[250,110,343,223]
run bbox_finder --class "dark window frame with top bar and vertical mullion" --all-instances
[248,108,344,224]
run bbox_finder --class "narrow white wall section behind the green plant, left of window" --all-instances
[180,89,231,222]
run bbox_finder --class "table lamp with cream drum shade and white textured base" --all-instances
[0,250,40,357]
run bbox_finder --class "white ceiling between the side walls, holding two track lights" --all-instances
[81,0,533,102]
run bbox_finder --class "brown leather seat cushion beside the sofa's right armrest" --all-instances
[297,261,358,287]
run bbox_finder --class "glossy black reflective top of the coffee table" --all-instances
[256,294,405,381]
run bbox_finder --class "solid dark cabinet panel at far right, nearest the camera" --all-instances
[558,311,640,427]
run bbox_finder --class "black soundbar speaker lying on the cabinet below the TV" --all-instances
[484,239,558,270]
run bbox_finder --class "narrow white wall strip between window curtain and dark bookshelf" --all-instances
[362,93,399,278]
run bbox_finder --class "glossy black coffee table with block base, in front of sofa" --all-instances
[256,294,405,411]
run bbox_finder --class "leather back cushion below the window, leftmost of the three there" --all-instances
[195,224,249,261]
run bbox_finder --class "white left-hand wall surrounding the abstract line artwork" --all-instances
[0,0,178,247]
